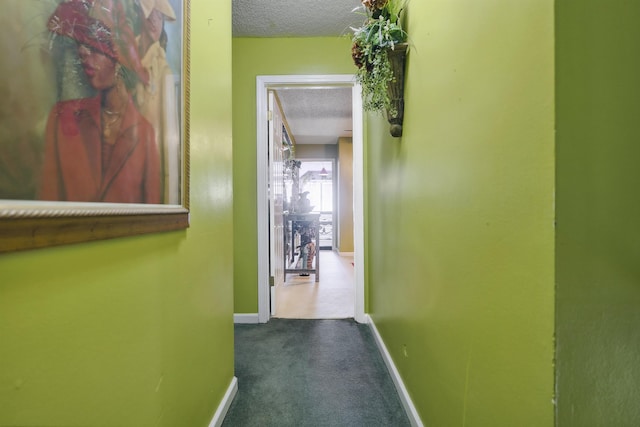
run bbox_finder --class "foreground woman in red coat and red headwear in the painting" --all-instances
[39,0,161,203]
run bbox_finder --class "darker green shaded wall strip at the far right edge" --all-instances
[556,0,640,427]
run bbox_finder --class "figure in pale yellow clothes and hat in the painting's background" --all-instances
[135,0,180,204]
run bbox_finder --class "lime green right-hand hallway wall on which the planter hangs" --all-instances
[367,0,554,427]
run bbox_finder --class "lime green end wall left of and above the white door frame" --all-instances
[233,37,354,313]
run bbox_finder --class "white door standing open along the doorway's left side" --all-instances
[269,90,285,316]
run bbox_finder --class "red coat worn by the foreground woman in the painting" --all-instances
[39,97,161,203]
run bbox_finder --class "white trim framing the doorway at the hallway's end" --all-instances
[256,74,366,323]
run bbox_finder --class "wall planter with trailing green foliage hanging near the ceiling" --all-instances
[351,0,408,137]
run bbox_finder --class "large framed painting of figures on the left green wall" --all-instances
[0,0,189,253]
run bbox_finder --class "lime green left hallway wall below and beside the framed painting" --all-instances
[0,1,234,427]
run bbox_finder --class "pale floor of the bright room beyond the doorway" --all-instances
[274,250,355,319]
